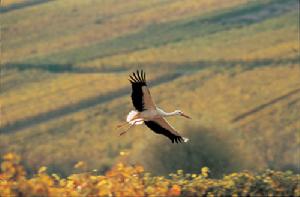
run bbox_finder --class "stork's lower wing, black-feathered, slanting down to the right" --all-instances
[145,118,188,143]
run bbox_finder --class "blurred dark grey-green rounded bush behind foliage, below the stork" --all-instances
[130,126,255,178]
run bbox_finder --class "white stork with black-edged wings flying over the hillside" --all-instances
[118,70,190,143]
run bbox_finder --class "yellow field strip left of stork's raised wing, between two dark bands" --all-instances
[0,73,164,126]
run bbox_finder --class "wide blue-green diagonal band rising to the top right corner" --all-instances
[17,0,297,64]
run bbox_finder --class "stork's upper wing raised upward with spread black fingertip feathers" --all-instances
[129,70,155,111]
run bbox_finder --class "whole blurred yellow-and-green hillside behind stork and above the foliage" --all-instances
[0,0,300,177]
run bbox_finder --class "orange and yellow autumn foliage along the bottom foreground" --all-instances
[0,153,300,196]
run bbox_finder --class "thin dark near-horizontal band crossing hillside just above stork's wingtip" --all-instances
[2,57,300,74]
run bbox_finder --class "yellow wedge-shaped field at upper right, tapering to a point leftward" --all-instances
[81,12,298,67]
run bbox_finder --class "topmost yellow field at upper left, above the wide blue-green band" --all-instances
[0,0,247,63]
